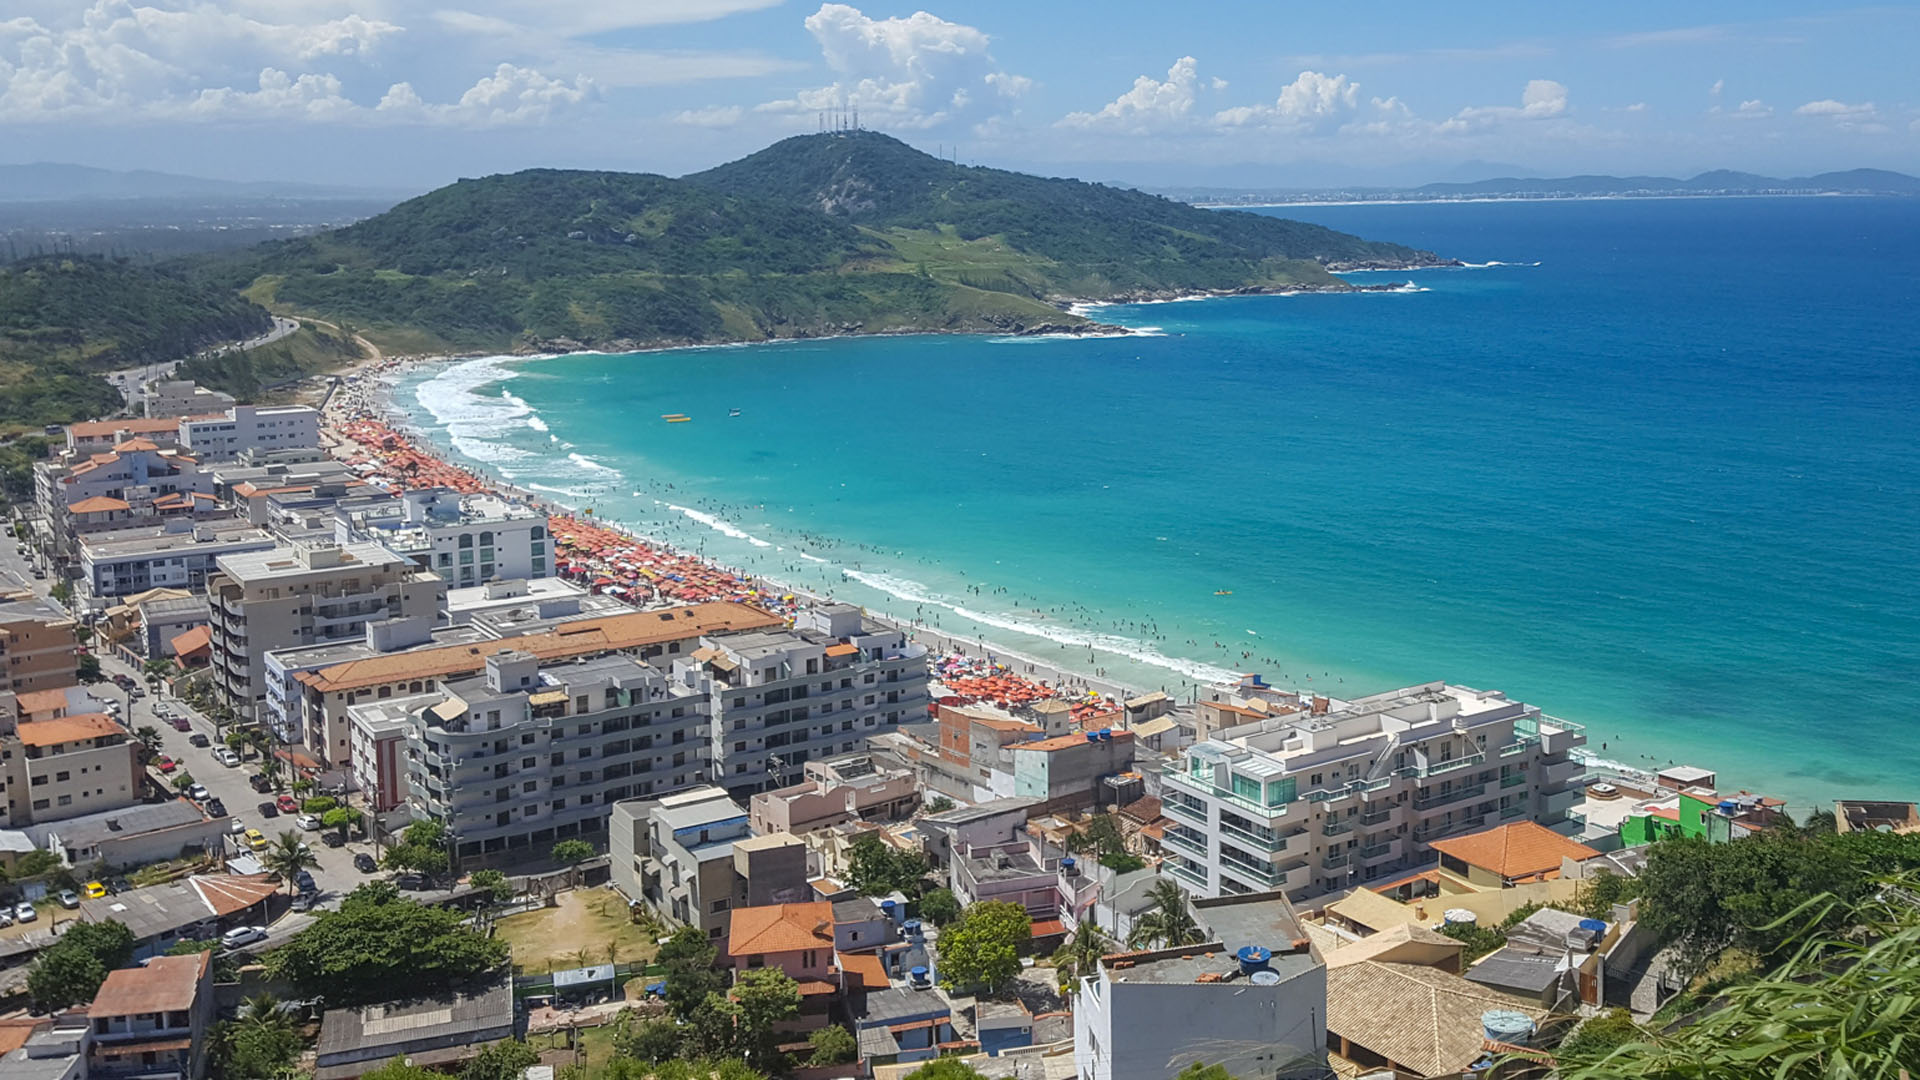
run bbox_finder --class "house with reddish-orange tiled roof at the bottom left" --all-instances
[86,953,213,1080]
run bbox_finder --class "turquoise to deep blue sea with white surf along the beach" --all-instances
[396,198,1920,811]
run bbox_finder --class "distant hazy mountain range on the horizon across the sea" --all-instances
[1160,169,1920,206]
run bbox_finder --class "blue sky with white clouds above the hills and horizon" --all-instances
[0,0,1920,188]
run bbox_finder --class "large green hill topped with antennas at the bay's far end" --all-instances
[186,133,1432,352]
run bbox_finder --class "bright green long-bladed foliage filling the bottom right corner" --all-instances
[1555,874,1920,1080]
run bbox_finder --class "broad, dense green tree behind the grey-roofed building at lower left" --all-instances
[271,882,507,1005]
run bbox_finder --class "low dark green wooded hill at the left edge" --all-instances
[0,256,271,429]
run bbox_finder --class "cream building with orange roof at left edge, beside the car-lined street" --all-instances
[0,713,142,828]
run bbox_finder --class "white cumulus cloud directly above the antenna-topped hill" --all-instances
[758,4,1033,127]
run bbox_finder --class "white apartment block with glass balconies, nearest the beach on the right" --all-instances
[1160,682,1586,899]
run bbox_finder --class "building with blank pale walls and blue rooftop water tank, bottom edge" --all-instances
[1073,892,1327,1080]
